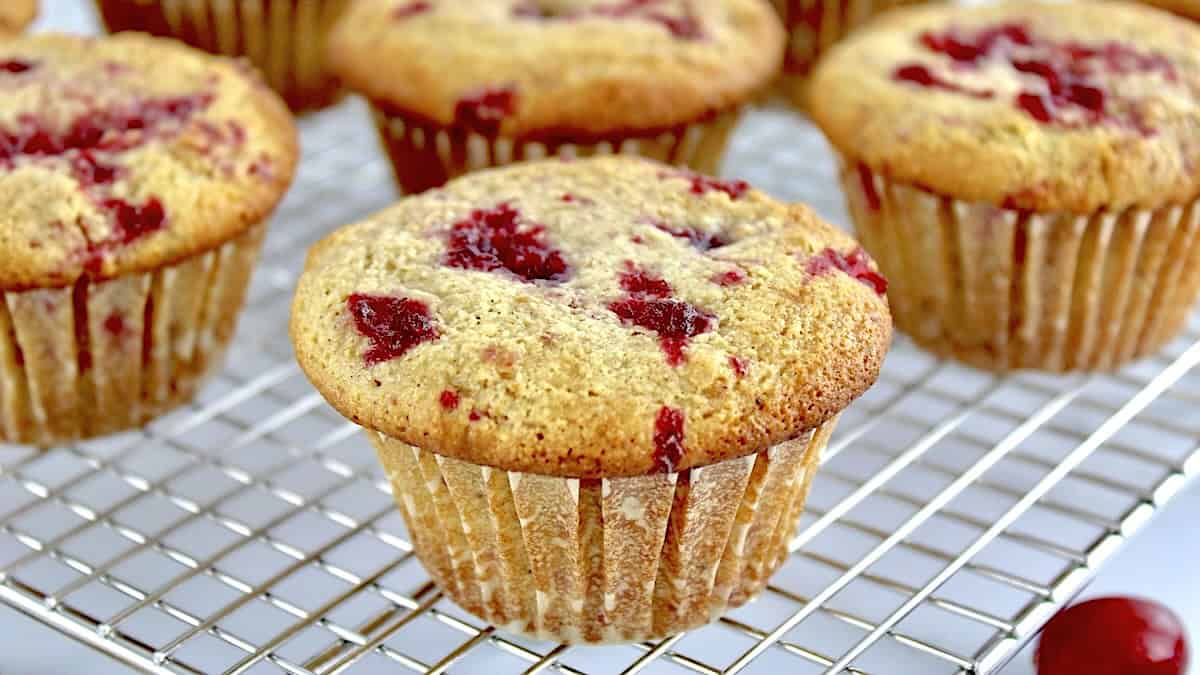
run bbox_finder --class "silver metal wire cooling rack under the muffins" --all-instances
[0,0,1200,675]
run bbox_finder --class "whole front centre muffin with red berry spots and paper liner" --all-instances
[292,157,892,643]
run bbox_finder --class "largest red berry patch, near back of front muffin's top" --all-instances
[443,202,569,281]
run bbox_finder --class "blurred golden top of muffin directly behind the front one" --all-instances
[329,0,785,136]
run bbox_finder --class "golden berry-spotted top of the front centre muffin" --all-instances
[292,156,892,477]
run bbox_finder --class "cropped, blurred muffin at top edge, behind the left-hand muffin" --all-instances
[96,0,350,110]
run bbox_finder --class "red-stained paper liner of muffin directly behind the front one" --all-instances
[371,101,742,195]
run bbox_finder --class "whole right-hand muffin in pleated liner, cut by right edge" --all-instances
[811,1,1200,371]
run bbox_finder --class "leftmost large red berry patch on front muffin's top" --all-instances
[346,293,442,365]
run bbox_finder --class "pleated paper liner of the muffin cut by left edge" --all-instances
[0,225,265,447]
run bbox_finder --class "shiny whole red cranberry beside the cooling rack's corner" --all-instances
[1034,598,1188,675]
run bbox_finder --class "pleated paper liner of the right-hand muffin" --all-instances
[841,165,1200,371]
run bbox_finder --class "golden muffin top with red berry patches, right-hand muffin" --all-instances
[811,1,1200,213]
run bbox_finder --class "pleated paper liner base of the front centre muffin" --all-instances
[368,419,836,644]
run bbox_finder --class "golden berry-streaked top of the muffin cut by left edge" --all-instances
[0,35,298,289]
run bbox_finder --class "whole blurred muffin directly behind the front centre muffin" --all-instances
[329,0,784,193]
